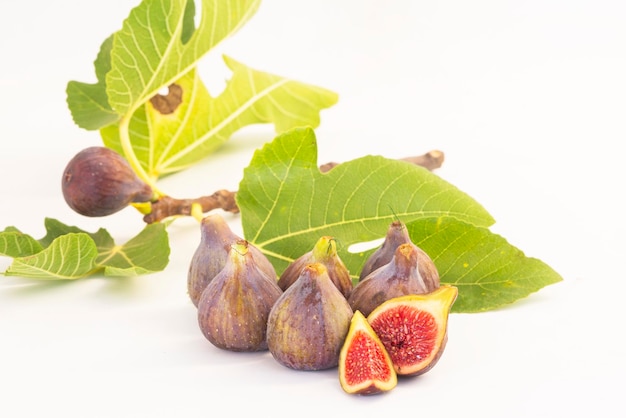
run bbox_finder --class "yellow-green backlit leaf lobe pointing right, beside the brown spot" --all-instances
[101,57,337,178]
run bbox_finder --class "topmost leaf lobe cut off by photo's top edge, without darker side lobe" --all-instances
[106,0,260,115]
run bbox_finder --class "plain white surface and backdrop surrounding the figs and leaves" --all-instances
[0,0,626,417]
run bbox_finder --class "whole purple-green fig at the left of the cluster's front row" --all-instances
[198,240,282,351]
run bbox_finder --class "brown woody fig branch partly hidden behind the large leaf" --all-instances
[141,149,444,224]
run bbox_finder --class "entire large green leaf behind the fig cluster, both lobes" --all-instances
[237,128,560,312]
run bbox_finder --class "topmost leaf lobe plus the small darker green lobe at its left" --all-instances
[66,0,260,130]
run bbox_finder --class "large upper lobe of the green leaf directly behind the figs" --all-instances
[237,128,493,277]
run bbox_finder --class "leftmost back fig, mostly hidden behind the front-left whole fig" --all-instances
[187,214,277,307]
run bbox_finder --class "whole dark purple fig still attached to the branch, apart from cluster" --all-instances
[61,146,154,217]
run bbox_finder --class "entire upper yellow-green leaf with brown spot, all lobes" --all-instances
[66,0,337,183]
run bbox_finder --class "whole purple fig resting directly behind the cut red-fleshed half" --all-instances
[348,243,439,316]
